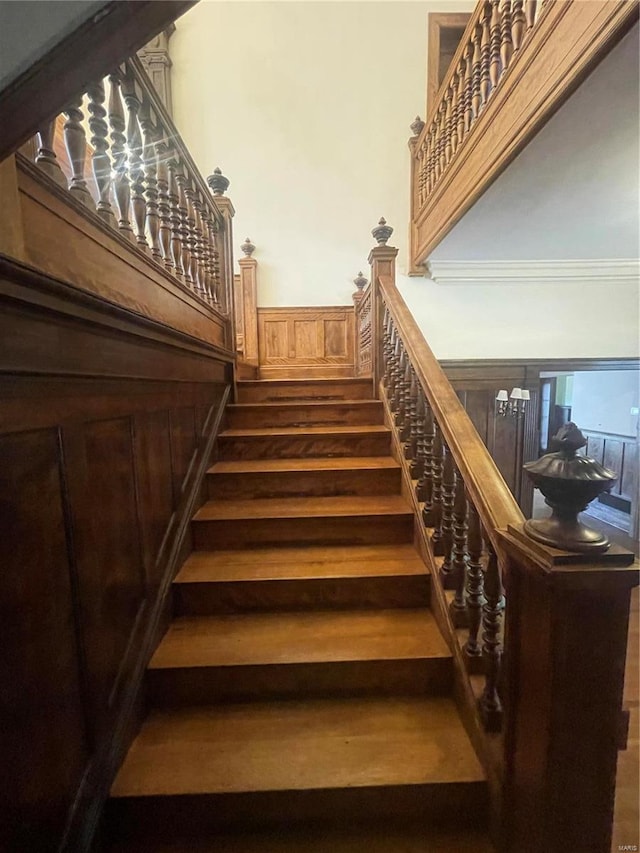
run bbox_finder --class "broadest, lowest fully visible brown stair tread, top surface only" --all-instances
[111,697,485,797]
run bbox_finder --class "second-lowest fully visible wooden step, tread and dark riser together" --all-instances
[148,609,451,707]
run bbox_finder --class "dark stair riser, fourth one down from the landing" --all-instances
[207,468,400,500]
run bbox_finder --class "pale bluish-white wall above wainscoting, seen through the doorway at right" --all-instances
[571,370,640,437]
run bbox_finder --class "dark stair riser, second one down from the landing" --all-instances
[226,400,384,429]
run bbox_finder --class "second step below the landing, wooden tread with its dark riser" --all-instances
[218,424,391,459]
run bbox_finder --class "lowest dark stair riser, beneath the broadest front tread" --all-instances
[109,784,489,836]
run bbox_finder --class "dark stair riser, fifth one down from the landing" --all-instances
[192,513,413,551]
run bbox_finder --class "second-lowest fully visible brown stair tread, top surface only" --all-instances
[149,608,451,669]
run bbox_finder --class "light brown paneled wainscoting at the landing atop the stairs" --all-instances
[258,305,355,379]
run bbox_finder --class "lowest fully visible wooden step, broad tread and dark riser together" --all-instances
[111,697,487,834]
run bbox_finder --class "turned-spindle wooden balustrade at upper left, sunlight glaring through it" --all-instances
[28,58,233,320]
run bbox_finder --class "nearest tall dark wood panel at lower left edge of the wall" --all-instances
[0,429,88,853]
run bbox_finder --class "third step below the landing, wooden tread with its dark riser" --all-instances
[207,456,401,499]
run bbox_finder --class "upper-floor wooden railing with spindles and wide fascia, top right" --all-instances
[409,0,638,266]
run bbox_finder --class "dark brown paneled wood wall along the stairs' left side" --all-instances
[0,262,230,853]
